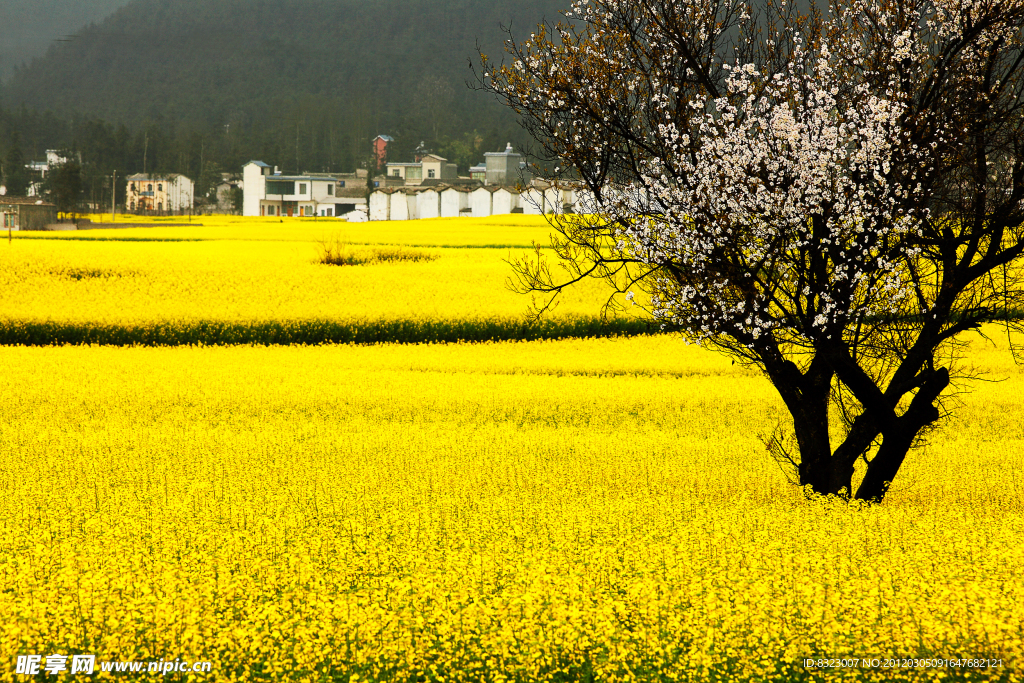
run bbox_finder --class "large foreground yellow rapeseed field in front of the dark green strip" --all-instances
[0,218,1024,682]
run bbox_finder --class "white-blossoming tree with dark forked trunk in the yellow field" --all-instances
[482,0,1024,501]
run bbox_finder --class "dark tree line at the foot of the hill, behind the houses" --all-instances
[0,102,524,207]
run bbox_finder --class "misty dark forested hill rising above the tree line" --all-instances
[0,0,568,171]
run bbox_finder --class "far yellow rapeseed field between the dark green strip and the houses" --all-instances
[0,217,643,342]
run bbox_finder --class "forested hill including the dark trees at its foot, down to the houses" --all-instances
[0,0,565,179]
